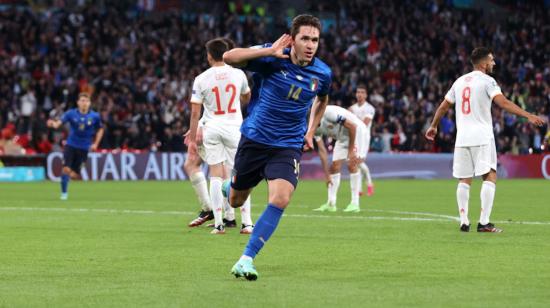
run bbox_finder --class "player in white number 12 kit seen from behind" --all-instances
[188,39,252,234]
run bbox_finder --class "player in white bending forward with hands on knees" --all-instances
[314,105,368,213]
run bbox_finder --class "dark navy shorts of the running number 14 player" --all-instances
[231,136,302,190]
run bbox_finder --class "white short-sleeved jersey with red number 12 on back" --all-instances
[191,65,250,126]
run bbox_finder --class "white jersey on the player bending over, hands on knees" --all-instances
[315,105,366,141]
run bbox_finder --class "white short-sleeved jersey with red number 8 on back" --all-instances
[445,71,502,147]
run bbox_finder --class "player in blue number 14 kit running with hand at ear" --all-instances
[223,15,332,280]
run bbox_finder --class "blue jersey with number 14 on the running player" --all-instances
[241,44,332,149]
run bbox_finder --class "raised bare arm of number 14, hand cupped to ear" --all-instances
[223,34,292,67]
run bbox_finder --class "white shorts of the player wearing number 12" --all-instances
[202,125,241,166]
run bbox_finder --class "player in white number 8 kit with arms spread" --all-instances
[426,47,544,232]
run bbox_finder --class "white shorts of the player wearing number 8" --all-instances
[453,139,497,179]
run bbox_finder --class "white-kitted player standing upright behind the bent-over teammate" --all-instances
[349,84,376,197]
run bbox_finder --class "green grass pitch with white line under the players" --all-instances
[0,180,550,307]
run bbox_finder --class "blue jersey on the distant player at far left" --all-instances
[61,108,103,151]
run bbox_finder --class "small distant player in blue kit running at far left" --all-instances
[47,93,103,200]
